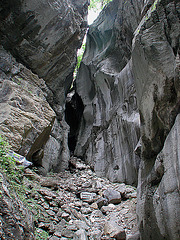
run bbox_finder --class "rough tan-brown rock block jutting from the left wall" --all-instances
[0,49,55,161]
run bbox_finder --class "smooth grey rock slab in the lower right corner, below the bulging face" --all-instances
[137,114,180,239]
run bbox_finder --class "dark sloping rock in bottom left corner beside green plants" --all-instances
[0,173,35,240]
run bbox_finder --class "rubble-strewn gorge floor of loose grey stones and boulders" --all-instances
[20,158,138,240]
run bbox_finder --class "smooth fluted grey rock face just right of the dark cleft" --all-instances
[75,0,143,184]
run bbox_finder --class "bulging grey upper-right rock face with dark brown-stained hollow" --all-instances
[132,1,180,159]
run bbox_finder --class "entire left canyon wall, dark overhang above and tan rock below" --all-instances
[0,0,88,174]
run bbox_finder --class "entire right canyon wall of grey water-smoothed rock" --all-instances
[75,0,180,240]
